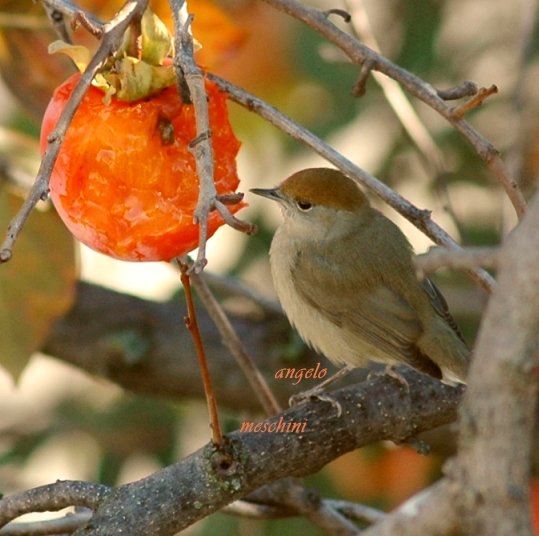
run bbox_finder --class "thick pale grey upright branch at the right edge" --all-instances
[451,195,539,536]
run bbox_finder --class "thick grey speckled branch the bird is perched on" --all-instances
[0,370,462,536]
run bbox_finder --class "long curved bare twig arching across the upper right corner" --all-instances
[265,0,526,219]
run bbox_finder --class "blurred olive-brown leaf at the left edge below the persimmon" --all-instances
[0,191,76,379]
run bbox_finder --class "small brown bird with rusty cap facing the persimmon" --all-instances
[251,168,470,383]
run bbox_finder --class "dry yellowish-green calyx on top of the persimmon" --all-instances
[49,8,176,103]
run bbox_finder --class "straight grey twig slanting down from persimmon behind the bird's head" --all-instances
[208,75,496,292]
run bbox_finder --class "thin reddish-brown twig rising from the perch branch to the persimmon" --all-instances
[176,259,224,446]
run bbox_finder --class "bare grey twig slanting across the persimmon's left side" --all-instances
[0,0,148,263]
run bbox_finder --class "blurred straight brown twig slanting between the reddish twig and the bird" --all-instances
[184,258,282,416]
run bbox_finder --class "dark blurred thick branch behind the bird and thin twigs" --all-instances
[42,282,338,412]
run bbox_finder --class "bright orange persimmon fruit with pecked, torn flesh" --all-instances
[41,74,243,261]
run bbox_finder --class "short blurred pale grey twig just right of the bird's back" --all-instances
[414,247,500,275]
